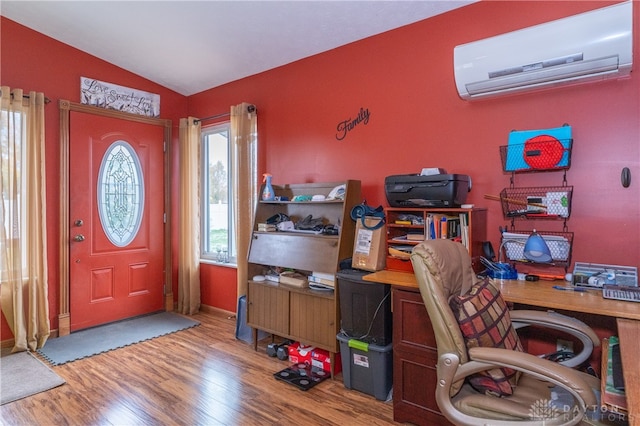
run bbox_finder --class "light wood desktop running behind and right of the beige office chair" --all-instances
[363,271,640,425]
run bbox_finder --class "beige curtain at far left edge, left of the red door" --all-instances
[0,86,50,352]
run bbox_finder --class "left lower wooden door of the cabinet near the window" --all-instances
[247,281,289,336]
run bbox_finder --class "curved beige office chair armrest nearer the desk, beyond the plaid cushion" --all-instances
[509,309,600,367]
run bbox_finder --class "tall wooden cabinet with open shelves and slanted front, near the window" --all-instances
[247,180,361,374]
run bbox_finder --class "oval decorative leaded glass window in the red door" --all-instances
[98,140,144,247]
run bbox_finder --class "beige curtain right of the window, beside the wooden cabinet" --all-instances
[230,102,258,297]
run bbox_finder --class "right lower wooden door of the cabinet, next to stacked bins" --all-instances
[290,292,338,352]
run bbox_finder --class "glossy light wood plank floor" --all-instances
[0,313,397,426]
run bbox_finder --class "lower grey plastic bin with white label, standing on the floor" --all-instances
[336,334,393,401]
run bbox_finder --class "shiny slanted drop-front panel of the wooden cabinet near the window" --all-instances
[249,232,338,272]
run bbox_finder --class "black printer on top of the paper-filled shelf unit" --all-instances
[384,174,471,208]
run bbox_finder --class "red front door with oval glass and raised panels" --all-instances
[69,112,164,331]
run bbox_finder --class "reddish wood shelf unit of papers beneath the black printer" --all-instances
[385,207,487,272]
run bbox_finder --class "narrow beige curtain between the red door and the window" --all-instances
[178,117,201,315]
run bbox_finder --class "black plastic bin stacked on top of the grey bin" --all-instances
[336,269,392,346]
